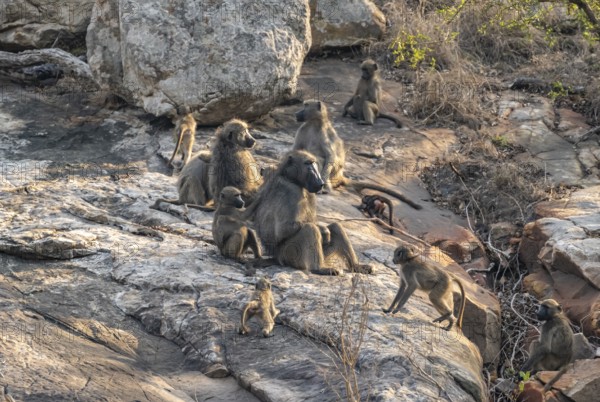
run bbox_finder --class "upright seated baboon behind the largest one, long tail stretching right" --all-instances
[293,100,422,209]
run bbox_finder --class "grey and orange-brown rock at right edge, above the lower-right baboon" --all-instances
[521,186,600,336]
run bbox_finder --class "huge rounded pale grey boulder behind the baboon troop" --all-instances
[87,0,311,125]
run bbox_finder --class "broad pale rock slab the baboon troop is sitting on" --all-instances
[0,61,500,401]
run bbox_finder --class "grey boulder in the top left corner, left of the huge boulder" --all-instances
[0,0,94,51]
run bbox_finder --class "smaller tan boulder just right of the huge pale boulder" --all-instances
[309,0,386,51]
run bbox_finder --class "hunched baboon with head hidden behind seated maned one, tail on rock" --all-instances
[152,151,214,211]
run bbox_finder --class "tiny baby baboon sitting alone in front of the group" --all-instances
[240,278,279,337]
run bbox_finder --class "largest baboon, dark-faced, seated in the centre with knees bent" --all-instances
[246,150,372,275]
